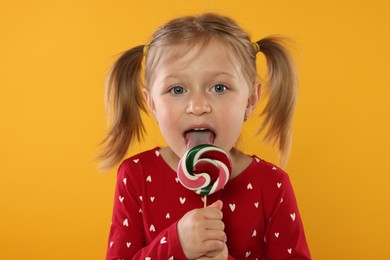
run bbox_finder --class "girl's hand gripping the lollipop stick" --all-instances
[177,200,227,259]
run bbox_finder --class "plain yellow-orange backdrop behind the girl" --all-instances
[0,0,390,260]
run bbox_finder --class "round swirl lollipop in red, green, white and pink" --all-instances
[177,144,231,206]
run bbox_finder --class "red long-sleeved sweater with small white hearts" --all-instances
[106,148,311,260]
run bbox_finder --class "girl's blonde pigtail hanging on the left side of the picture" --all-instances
[98,45,146,170]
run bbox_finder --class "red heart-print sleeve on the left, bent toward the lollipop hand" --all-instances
[106,162,185,260]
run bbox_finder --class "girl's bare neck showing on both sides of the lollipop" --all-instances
[160,147,253,179]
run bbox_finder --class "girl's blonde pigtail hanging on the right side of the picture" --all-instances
[257,36,298,167]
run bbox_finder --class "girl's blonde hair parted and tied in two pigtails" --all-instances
[99,13,297,169]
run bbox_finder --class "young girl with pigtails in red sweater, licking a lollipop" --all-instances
[101,14,310,260]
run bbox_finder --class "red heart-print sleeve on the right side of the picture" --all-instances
[265,173,311,260]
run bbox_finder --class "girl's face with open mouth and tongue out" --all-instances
[145,40,259,158]
